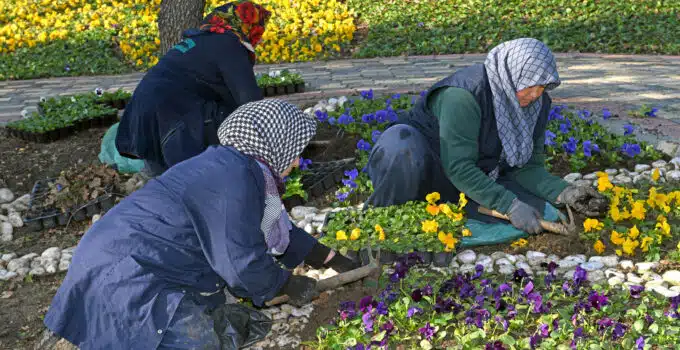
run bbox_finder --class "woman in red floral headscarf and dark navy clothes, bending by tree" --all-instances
[116,1,271,177]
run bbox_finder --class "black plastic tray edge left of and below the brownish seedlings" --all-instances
[24,179,116,231]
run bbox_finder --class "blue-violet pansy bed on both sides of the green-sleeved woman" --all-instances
[314,90,667,203]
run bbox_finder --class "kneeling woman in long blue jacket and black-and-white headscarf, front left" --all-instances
[45,100,355,349]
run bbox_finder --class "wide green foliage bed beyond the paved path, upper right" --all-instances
[348,0,680,57]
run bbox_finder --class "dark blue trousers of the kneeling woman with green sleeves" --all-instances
[366,124,546,224]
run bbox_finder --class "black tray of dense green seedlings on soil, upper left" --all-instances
[7,93,118,143]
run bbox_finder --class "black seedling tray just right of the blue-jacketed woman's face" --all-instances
[282,158,354,210]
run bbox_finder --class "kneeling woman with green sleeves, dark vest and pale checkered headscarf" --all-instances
[367,38,606,244]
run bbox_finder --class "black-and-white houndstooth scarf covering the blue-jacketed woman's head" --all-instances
[217,99,316,175]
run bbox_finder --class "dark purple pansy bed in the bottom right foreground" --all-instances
[310,255,680,350]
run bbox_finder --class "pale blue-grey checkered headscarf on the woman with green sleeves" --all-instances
[484,38,560,172]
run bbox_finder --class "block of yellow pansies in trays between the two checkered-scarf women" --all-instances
[320,192,471,266]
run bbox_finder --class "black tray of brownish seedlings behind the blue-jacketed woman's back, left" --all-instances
[24,165,119,231]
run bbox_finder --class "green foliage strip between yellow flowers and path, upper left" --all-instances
[0,31,132,81]
